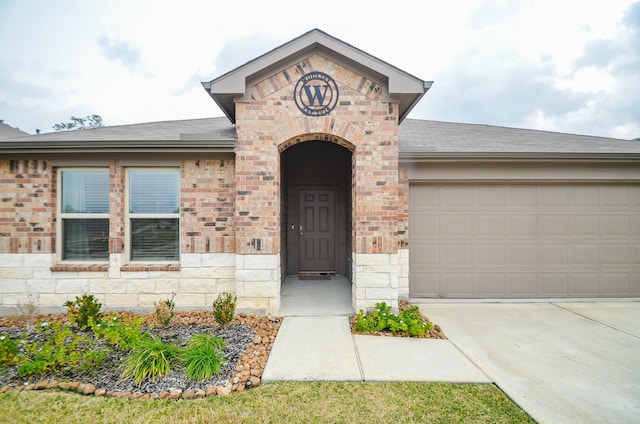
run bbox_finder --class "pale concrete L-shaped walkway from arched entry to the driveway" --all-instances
[262,316,490,383]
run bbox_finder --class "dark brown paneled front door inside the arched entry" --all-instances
[298,190,335,271]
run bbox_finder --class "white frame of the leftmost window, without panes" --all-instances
[56,166,111,264]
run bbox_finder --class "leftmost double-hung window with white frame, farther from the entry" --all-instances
[58,169,109,261]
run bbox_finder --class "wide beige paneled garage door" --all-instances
[409,184,640,298]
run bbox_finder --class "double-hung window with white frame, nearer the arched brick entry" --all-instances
[127,169,180,262]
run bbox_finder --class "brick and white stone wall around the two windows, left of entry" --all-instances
[0,159,238,313]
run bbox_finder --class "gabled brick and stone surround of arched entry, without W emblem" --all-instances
[236,54,398,312]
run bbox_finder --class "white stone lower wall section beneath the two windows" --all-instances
[0,253,236,313]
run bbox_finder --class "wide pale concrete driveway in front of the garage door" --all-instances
[414,301,640,423]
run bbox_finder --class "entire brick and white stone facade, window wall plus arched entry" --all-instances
[0,36,408,313]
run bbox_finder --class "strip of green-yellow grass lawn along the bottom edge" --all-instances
[0,382,534,424]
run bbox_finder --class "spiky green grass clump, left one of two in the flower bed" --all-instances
[122,337,181,384]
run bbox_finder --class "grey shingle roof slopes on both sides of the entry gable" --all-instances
[0,117,640,157]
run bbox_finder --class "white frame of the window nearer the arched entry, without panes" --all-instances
[124,166,181,264]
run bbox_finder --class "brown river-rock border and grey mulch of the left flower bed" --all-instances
[0,311,282,399]
